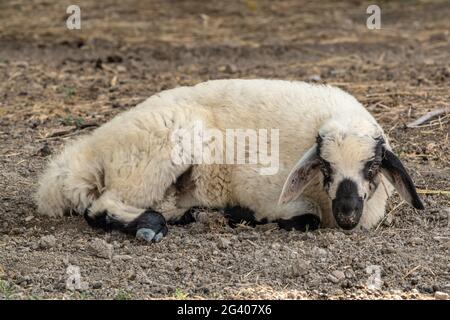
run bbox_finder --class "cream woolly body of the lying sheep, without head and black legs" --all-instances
[37,80,391,228]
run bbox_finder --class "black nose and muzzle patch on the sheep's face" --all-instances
[332,179,364,230]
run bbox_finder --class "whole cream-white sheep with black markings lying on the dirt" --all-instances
[36,79,423,242]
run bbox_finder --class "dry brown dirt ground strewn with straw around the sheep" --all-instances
[0,0,450,299]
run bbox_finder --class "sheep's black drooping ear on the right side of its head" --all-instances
[381,147,424,210]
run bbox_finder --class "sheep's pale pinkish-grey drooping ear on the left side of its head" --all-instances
[278,144,320,204]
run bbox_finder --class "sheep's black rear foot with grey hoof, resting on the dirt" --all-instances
[135,210,168,242]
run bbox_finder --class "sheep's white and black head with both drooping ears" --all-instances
[280,118,423,230]
